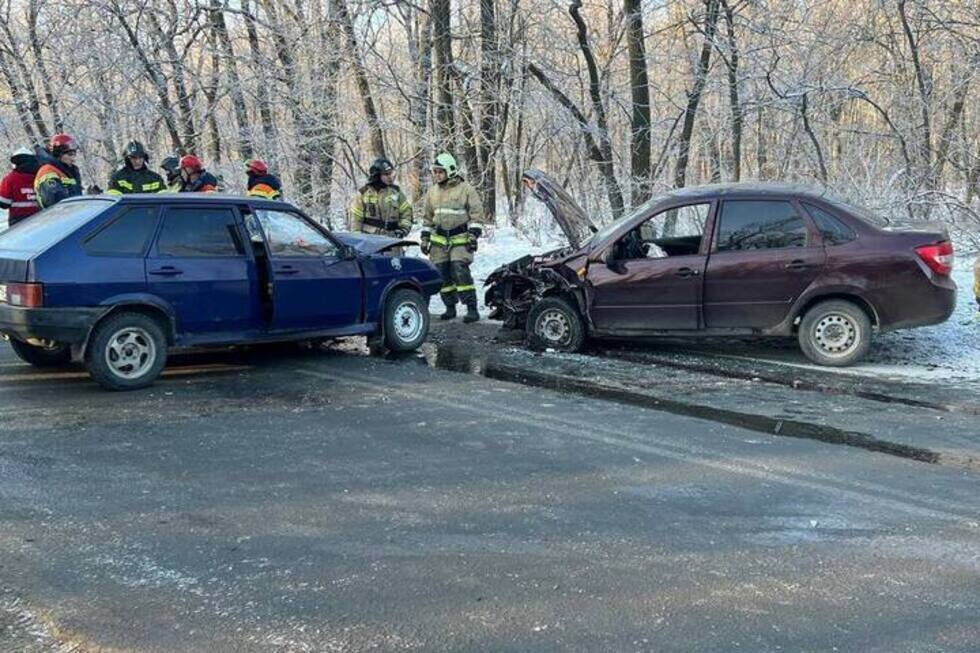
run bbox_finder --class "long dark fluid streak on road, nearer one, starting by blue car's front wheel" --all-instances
[384,342,940,463]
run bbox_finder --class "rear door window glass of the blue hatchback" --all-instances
[157,208,245,258]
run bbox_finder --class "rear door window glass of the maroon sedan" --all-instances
[716,200,807,252]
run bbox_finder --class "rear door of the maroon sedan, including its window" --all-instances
[704,199,826,329]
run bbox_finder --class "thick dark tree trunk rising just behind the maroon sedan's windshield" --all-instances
[625,0,652,206]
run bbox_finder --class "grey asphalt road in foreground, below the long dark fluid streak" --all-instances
[0,338,980,653]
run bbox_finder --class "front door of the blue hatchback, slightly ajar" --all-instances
[255,209,364,331]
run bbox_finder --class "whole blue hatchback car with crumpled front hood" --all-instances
[0,193,442,390]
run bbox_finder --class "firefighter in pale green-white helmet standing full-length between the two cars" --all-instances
[421,152,484,322]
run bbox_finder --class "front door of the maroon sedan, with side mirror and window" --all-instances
[588,202,712,331]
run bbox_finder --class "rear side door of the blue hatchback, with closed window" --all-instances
[145,204,257,337]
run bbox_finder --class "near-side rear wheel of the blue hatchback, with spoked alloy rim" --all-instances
[85,312,167,390]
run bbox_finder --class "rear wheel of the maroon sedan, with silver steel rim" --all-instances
[798,299,873,367]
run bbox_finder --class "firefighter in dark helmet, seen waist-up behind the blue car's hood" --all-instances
[350,158,412,238]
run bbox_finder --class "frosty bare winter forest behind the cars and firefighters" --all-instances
[0,0,980,246]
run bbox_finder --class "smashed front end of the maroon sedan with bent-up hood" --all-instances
[485,170,596,329]
